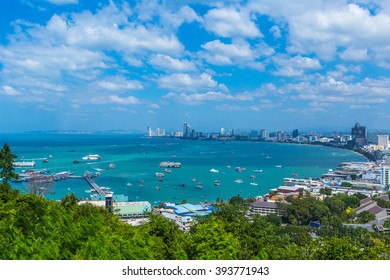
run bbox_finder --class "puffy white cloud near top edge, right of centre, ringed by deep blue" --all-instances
[204,7,263,38]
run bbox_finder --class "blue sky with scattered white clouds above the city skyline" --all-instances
[0,0,390,132]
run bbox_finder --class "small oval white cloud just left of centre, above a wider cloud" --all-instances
[149,54,196,72]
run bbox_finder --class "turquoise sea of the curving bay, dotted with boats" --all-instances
[0,134,366,204]
